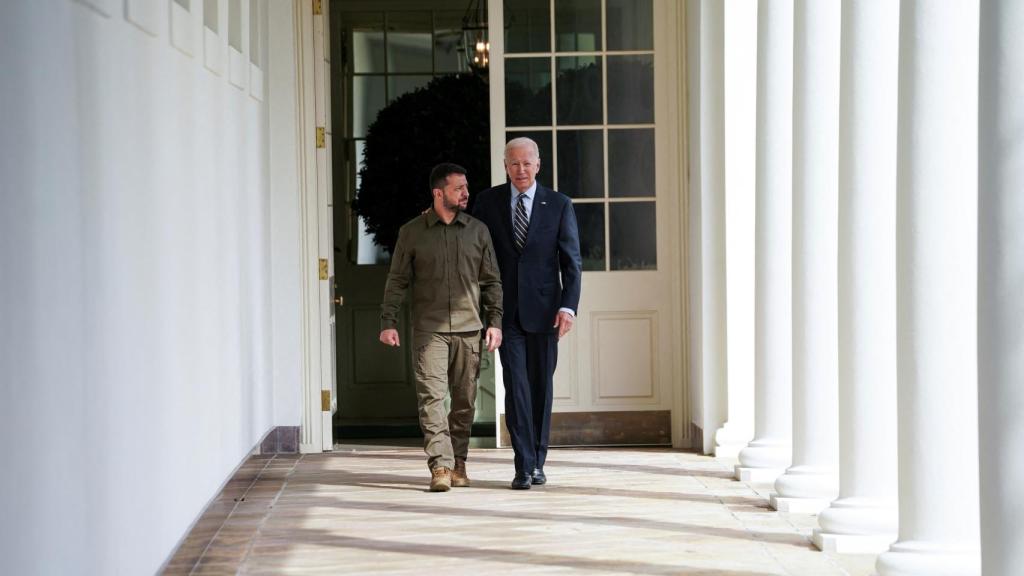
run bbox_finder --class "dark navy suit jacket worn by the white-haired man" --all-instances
[473,182,583,333]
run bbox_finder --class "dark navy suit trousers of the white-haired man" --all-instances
[499,318,558,474]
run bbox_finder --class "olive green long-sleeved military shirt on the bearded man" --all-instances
[381,209,502,332]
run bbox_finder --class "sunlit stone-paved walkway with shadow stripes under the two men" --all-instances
[166,447,873,576]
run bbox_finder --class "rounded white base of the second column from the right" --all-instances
[874,540,981,576]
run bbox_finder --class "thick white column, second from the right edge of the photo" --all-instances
[877,0,983,576]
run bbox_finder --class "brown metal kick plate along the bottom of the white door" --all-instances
[501,410,672,447]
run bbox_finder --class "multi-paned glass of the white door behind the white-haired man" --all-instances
[505,0,657,271]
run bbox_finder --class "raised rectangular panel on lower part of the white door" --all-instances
[591,311,658,406]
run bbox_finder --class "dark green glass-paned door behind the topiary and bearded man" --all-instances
[330,0,495,442]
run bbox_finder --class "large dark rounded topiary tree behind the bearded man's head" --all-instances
[352,74,490,252]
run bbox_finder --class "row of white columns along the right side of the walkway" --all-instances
[690,0,1024,576]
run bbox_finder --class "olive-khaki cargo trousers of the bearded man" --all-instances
[413,330,480,469]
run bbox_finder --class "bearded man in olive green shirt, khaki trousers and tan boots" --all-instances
[380,163,502,492]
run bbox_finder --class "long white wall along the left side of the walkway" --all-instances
[0,0,299,574]
